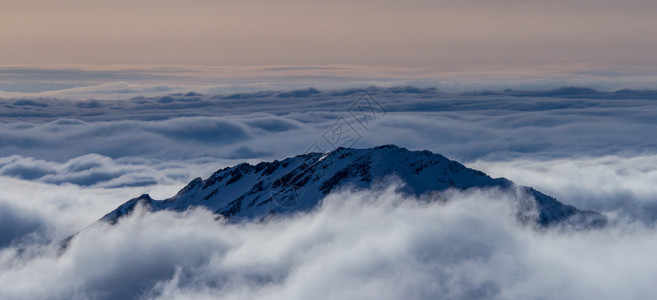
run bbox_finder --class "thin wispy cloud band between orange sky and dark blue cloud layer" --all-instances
[0,64,657,100]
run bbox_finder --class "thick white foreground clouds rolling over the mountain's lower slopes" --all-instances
[0,187,657,299]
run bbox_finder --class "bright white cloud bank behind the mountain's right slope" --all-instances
[470,155,657,224]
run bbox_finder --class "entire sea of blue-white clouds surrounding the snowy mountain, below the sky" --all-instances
[0,87,657,299]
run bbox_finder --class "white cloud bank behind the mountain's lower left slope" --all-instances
[0,176,185,248]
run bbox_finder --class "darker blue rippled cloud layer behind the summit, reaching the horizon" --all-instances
[0,87,657,162]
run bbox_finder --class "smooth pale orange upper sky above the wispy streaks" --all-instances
[5,0,657,71]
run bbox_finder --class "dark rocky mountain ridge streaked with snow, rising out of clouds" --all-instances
[101,145,606,227]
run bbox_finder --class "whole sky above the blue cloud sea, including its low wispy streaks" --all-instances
[0,0,657,97]
